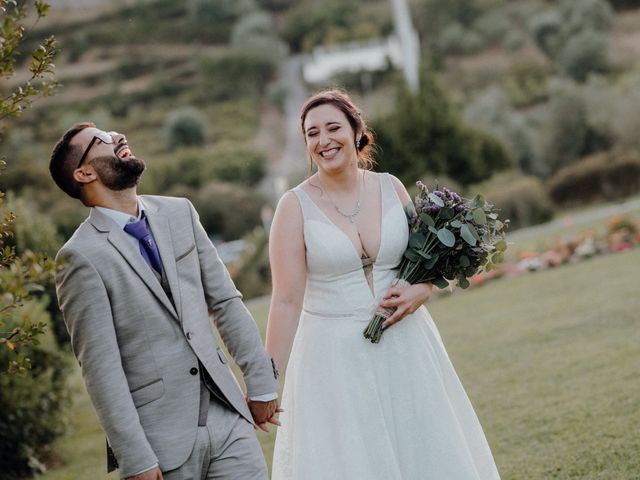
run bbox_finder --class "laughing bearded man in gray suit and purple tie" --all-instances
[49,123,279,480]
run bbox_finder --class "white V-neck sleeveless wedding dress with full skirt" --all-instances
[271,174,500,480]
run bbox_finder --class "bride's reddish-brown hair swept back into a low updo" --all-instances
[300,88,376,169]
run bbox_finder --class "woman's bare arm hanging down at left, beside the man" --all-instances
[266,192,307,376]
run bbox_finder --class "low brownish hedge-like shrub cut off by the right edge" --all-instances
[547,152,640,205]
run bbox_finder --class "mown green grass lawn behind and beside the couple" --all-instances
[41,249,640,480]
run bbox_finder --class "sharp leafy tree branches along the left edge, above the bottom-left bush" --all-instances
[0,0,58,376]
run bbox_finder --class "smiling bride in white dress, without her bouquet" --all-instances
[267,90,499,480]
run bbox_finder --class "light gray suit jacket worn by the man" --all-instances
[56,196,278,477]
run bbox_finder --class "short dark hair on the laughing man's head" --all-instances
[49,122,95,199]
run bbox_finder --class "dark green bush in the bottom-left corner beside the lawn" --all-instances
[0,301,69,480]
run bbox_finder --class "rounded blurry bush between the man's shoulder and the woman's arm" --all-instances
[193,181,266,240]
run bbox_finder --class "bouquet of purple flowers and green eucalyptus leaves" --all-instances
[364,181,509,343]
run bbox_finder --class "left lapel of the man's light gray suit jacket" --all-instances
[89,208,178,319]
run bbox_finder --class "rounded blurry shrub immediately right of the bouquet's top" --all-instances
[482,176,553,230]
